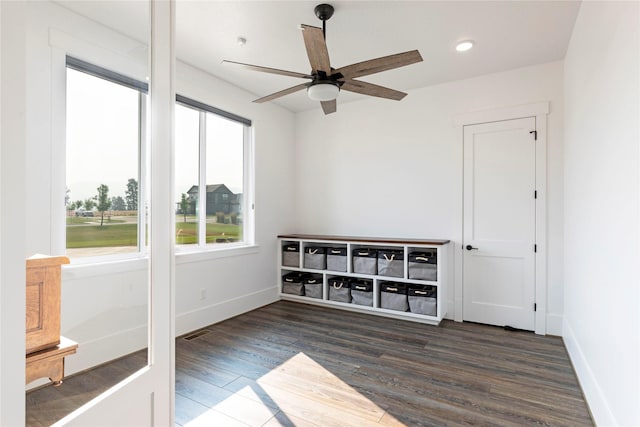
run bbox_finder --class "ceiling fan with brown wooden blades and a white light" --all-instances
[222,4,422,114]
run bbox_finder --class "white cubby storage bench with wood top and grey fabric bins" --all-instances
[278,234,450,325]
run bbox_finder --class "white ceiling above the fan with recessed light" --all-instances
[60,0,580,112]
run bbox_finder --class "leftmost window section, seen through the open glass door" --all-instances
[65,57,146,257]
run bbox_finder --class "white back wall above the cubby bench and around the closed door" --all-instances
[296,62,563,335]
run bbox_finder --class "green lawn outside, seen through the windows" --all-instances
[67,221,242,248]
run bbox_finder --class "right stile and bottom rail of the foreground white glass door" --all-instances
[55,0,175,426]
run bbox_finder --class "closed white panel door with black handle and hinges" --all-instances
[462,117,536,330]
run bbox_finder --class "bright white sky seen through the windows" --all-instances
[66,69,243,208]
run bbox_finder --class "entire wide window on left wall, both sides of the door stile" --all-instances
[65,57,253,257]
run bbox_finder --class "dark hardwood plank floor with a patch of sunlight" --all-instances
[27,301,593,427]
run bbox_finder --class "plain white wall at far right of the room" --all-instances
[563,2,640,426]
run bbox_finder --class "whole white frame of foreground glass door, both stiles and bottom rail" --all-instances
[0,0,175,426]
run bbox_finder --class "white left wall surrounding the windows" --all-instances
[25,2,294,384]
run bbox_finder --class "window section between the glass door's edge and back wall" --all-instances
[175,96,253,248]
